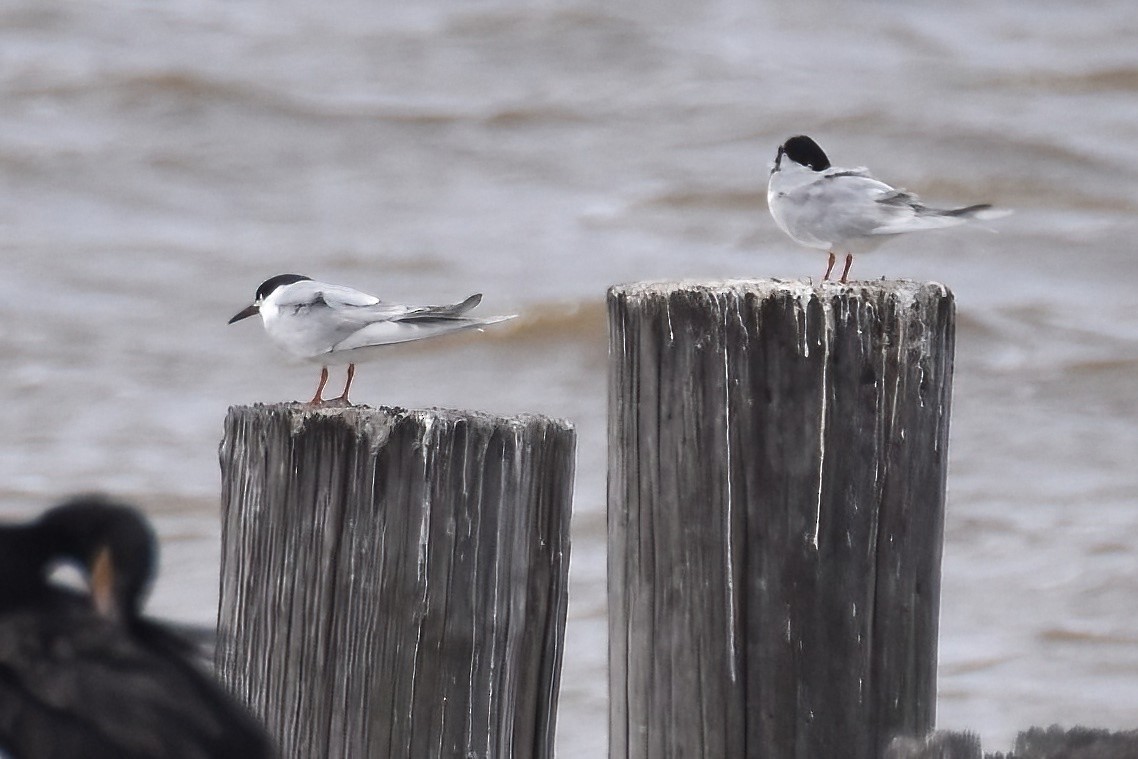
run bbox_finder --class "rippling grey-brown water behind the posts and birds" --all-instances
[0,0,1138,758]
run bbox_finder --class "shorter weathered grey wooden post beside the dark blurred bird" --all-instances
[217,404,575,758]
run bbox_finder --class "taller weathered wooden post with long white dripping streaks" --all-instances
[609,280,955,759]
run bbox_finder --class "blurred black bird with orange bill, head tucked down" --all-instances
[0,496,274,759]
